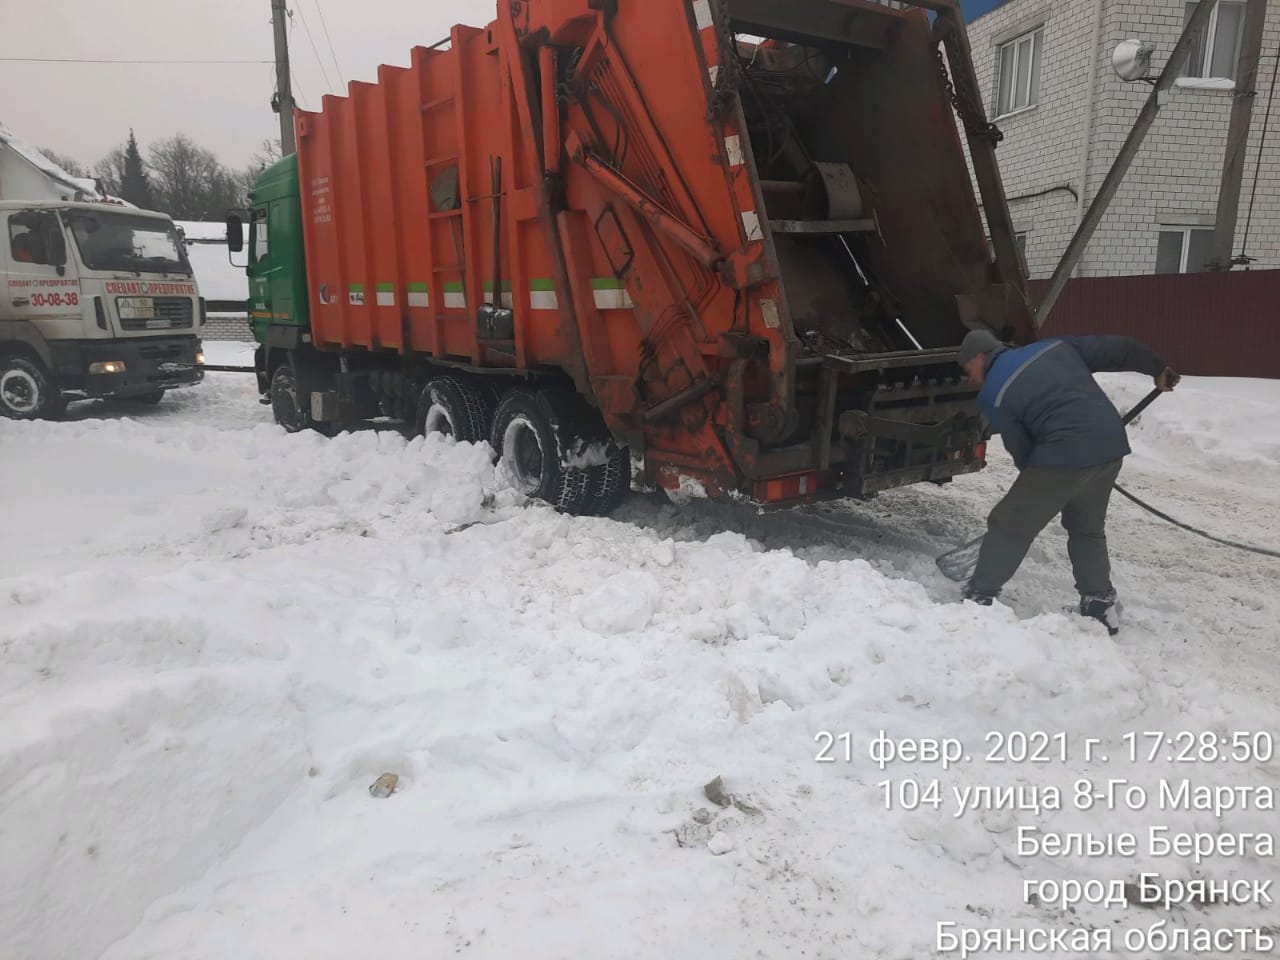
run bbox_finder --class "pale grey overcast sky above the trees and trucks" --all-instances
[0,0,495,168]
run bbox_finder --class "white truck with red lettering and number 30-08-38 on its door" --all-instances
[0,200,206,420]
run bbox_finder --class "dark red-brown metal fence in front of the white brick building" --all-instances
[1030,270,1280,379]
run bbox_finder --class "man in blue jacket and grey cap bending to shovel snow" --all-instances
[960,330,1180,635]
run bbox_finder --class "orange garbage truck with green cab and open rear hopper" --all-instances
[244,0,1032,513]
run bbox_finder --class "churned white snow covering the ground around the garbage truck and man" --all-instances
[0,355,1280,960]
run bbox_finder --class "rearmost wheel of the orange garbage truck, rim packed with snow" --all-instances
[492,389,589,513]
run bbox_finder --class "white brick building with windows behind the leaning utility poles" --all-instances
[969,0,1280,279]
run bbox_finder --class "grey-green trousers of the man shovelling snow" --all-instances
[969,460,1124,596]
